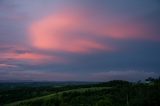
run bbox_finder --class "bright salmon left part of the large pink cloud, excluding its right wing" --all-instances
[29,12,113,53]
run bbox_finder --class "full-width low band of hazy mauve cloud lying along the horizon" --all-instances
[0,70,158,82]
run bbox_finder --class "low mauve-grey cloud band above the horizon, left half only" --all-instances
[0,70,76,81]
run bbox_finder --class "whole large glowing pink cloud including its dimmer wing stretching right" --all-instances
[29,11,158,52]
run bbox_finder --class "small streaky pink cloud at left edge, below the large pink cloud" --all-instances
[0,45,64,64]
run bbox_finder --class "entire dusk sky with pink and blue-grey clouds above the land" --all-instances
[0,0,160,81]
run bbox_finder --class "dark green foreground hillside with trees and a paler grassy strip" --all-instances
[0,78,160,106]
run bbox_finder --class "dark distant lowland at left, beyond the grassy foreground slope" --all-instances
[0,82,95,106]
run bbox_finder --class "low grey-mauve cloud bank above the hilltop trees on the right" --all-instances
[91,70,158,81]
